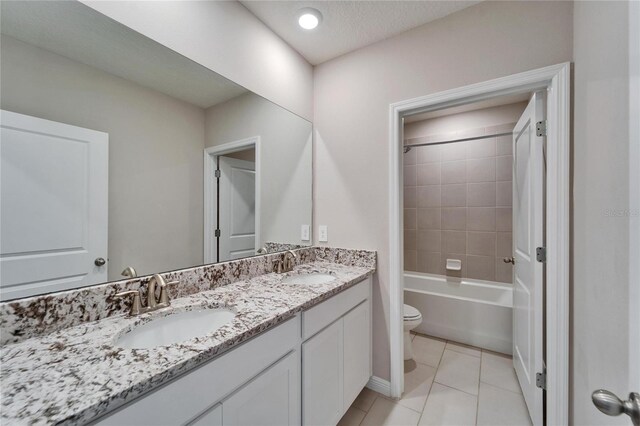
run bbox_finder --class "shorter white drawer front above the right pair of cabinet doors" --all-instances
[302,278,371,340]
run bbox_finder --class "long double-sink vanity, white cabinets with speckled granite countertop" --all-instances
[0,248,375,425]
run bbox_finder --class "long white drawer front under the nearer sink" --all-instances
[95,316,300,425]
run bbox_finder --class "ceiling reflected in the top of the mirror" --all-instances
[0,1,247,108]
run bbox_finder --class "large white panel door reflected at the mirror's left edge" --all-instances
[0,111,109,300]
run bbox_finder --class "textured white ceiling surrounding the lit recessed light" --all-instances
[240,0,480,65]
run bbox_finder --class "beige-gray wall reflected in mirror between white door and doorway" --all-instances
[1,36,205,280]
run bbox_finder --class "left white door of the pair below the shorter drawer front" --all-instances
[302,319,343,426]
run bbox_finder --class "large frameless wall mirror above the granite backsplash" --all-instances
[0,1,312,299]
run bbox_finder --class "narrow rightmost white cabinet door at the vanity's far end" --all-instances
[343,300,371,412]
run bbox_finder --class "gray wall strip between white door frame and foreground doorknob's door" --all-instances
[571,2,640,425]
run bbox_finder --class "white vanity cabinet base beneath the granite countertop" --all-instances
[96,278,371,425]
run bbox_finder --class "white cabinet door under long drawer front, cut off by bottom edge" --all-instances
[222,351,300,426]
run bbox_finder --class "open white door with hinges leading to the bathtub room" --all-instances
[513,93,545,425]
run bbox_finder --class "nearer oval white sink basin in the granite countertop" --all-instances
[116,309,236,349]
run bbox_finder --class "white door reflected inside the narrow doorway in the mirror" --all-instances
[218,156,256,262]
